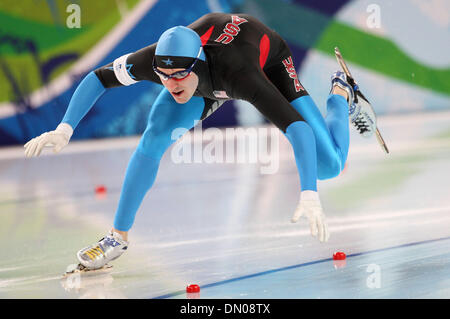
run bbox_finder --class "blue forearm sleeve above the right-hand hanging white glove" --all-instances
[285,121,317,191]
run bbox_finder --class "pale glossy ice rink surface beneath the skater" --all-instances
[0,112,450,299]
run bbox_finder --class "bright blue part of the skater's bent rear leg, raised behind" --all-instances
[291,94,349,179]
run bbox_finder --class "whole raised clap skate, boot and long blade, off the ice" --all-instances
[332,47,389,154]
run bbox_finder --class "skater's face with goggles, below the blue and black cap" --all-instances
[158,68,198,104]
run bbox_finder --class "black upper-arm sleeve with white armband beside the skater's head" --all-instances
[94,43,161,88]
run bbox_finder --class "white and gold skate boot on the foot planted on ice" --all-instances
[77,231,128,270]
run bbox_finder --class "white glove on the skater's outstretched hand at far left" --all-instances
[23,123,73,157]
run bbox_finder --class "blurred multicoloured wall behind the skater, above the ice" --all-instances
[0,0,450,146]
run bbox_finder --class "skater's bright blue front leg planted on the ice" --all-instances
[114,89,205,236]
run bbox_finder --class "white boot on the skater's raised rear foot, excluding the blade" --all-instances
[331,71,377,137]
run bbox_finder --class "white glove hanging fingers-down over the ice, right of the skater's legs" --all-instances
[291,191,330,242]
